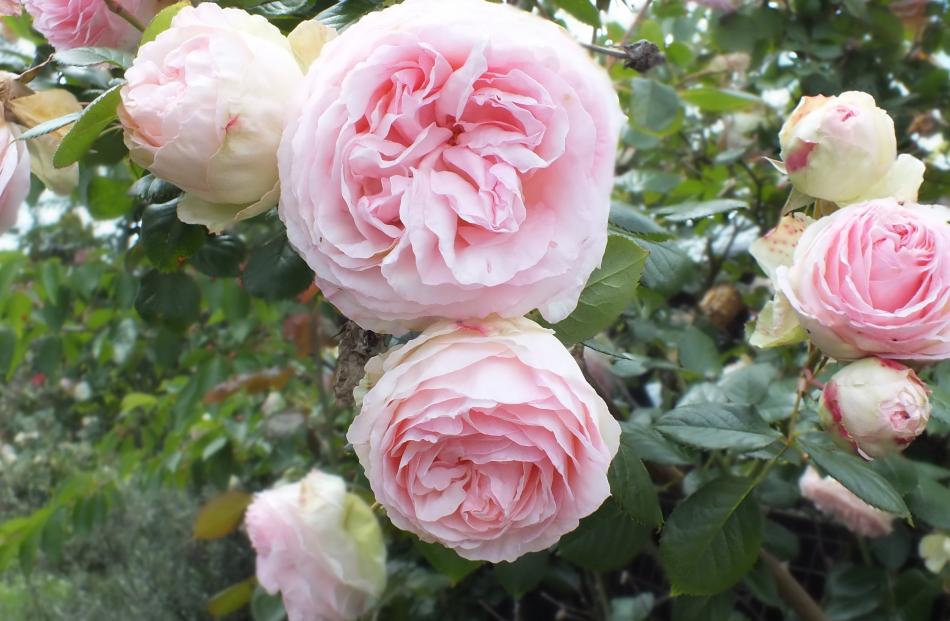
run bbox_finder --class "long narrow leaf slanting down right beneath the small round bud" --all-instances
[798,434,910,517]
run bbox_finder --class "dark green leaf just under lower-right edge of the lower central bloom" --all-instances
[558,498,652,571]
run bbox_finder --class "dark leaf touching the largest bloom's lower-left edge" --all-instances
[241,233,313,300]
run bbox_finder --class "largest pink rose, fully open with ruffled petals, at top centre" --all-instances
[279,0,623,333]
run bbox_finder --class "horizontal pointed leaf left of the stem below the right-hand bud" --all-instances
[654,403,782,451]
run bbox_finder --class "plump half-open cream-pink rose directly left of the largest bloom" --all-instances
[119,3,303,231]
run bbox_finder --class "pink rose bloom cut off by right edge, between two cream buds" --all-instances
[776,199,950,361]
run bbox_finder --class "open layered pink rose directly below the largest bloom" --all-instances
[347,318,620,562]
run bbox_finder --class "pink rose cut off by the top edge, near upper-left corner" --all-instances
[23,0,168,52]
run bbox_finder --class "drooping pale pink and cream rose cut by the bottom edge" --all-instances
[245,470,386,621]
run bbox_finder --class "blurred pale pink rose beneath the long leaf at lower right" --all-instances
[798,466,894,537]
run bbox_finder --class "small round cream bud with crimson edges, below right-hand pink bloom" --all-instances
[818,358,930,459]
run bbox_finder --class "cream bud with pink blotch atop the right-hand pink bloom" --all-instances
[779,91,924,203]
